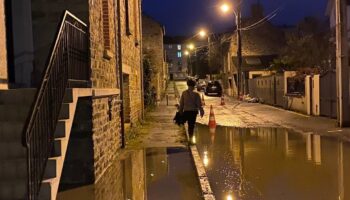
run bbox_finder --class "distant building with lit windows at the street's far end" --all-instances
[164,37,189,80]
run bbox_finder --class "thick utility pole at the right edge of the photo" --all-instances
[335,0,350,127]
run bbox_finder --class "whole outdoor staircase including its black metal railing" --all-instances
[0,11,92,200]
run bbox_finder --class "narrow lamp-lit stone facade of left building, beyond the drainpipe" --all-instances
[120,0,143,124]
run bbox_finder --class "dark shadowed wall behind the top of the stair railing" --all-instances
[32,0,89,84]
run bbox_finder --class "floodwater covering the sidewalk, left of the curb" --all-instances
[58,148,202,200]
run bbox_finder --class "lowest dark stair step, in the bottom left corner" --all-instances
[0,179,27,200]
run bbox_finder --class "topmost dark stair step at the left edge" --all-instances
[0,88,36,105]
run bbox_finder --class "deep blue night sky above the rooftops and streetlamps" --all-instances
[143,0,328,35]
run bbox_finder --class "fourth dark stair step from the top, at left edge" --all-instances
[0,141,26,161]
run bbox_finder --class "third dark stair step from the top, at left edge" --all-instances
[0,121,24,142]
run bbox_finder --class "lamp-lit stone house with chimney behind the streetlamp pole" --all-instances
[222,4,285,96]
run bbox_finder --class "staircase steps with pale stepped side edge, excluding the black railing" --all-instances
[0,89,92,200]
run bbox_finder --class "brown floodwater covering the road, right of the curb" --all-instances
[196,125,350,200]
